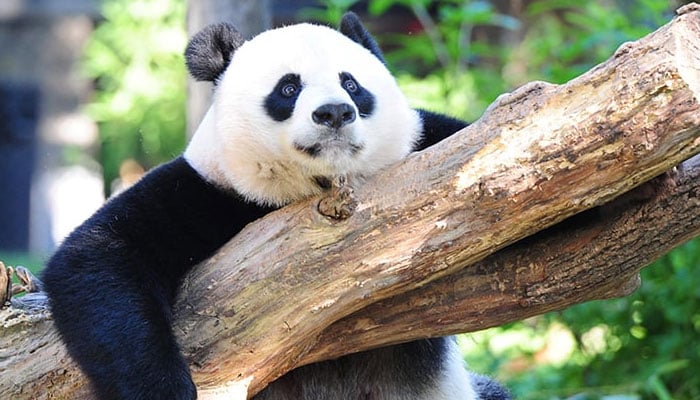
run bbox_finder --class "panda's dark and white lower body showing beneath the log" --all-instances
[254,337,482,400]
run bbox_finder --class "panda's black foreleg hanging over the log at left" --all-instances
[43,157,272,400]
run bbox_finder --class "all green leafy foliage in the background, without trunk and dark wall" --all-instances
[9,0,700,400]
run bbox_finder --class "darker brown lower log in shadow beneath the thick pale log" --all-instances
[303,156,700,363]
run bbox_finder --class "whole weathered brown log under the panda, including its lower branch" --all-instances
[0,5,700,399]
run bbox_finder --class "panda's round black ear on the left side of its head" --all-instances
[185,22,245,83]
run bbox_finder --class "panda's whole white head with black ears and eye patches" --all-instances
[185,14,421,205]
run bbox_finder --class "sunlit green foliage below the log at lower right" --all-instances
[463,239,700,399]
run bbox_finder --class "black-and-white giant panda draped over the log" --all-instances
[43,13,508,400]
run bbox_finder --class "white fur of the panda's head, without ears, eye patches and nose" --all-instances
[185,24,421,205]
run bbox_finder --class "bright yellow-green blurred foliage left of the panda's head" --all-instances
[83,0,187,192]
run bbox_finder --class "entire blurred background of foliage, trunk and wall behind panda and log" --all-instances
[0,0,700,400]
